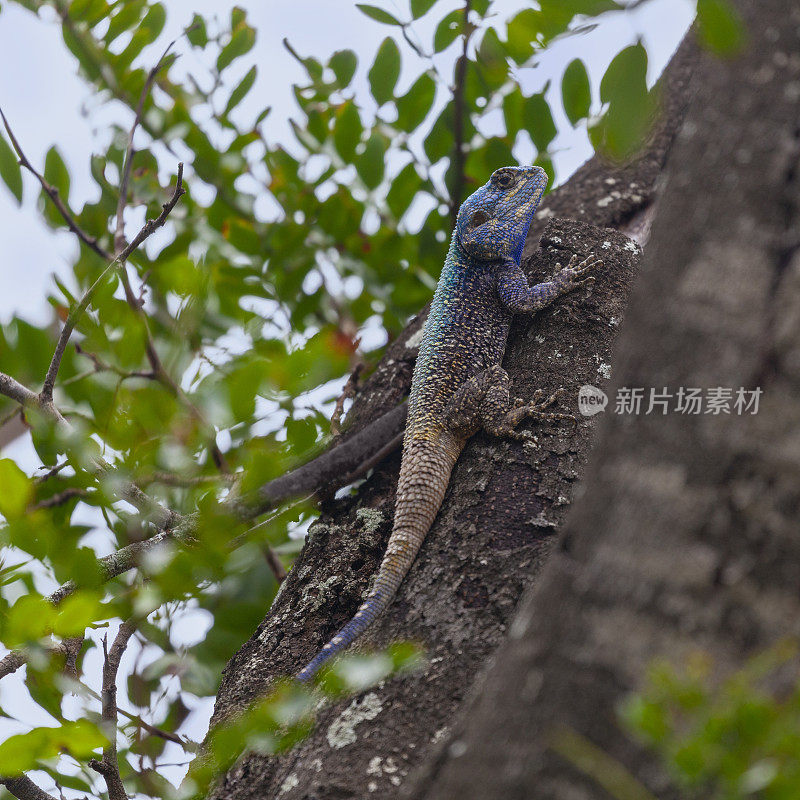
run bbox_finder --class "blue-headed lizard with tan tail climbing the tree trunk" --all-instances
[297,166,602,682]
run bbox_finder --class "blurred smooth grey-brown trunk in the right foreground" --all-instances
[412,0,800,800]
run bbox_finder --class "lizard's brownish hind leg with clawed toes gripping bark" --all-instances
[446,365,577,441]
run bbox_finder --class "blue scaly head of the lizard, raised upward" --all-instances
[453,167,547,263]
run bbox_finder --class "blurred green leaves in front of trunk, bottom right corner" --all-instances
[623,642,800,800]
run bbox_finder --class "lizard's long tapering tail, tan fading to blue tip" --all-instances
[297,442,460,681]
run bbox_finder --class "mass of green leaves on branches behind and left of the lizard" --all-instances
[0,0,739,796]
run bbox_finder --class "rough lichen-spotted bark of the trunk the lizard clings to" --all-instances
[205,32,695,800]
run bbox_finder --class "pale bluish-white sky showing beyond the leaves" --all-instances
[0,0,693,788]
